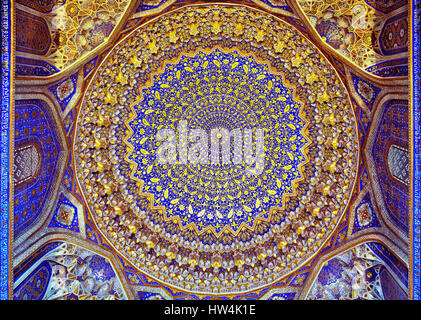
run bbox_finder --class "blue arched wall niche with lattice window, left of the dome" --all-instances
[13,94,69,255]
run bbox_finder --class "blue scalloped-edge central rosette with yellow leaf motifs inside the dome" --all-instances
[125,49,308,233]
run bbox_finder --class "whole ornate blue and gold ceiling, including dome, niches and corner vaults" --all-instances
[1,0,413,300]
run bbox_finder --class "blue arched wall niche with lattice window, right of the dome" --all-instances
[365,98,410,241]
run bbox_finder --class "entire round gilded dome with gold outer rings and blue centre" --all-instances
[74,5,358,294]
